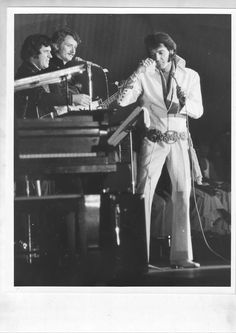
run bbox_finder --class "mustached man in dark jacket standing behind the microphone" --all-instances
[47,28,108,109]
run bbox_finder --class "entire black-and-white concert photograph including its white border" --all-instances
[1,2,235,332]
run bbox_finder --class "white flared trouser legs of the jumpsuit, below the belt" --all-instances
[137,137,193,262]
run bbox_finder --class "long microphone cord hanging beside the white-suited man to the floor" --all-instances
[185,113,230,264]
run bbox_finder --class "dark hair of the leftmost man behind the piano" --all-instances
[21,34,51,61]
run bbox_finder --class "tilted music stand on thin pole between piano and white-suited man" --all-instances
[107,106,143,194]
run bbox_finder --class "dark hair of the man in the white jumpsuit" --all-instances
[144,32,177,53]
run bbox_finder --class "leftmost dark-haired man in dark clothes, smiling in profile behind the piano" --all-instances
[15,34,86,118]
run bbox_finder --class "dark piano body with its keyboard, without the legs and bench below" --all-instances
[15,110,118,176]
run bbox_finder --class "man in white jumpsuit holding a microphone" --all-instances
[118,33,203,268]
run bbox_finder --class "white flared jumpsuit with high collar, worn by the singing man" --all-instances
[118,56,203,262]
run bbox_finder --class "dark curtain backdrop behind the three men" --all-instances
[15,14,231,143]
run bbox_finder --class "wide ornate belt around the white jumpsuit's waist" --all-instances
[146,128,188,144]
